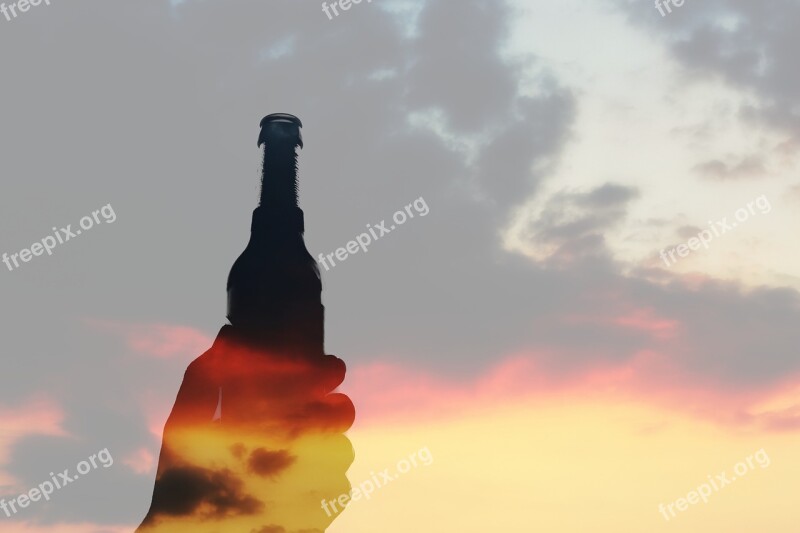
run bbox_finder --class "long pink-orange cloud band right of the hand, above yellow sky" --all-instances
[343,350,800,431]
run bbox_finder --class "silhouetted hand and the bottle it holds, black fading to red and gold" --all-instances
[137,113,355,533]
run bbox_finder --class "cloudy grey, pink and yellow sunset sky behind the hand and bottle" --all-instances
[0,0,800,533]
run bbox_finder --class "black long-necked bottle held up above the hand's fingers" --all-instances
[228,114,324,356]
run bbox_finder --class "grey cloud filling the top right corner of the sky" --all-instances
[616,0,800,135]
